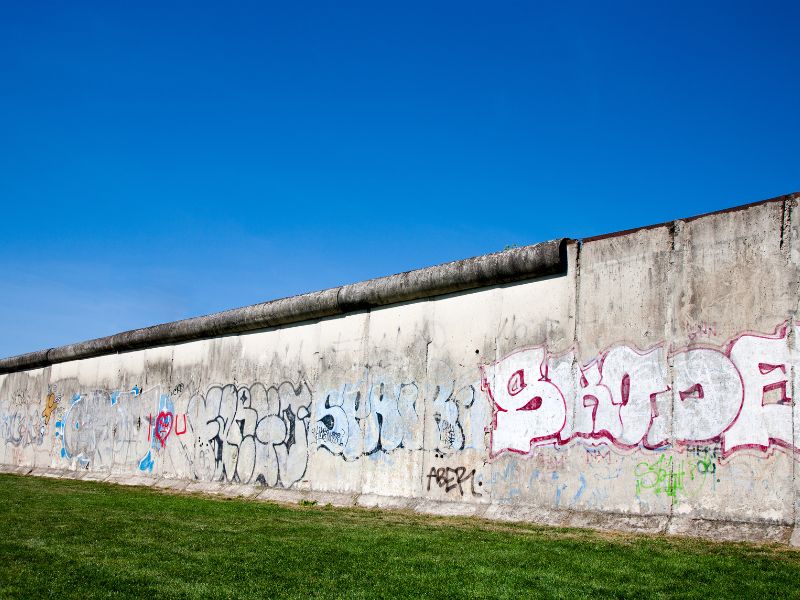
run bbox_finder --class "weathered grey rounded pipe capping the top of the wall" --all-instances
[0,238,572,374]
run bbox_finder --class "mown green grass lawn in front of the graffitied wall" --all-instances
[0,475,800,600]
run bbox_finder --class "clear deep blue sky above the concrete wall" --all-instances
[0,1,800,356]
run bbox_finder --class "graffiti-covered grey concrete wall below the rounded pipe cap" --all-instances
[0,195,800,543]
